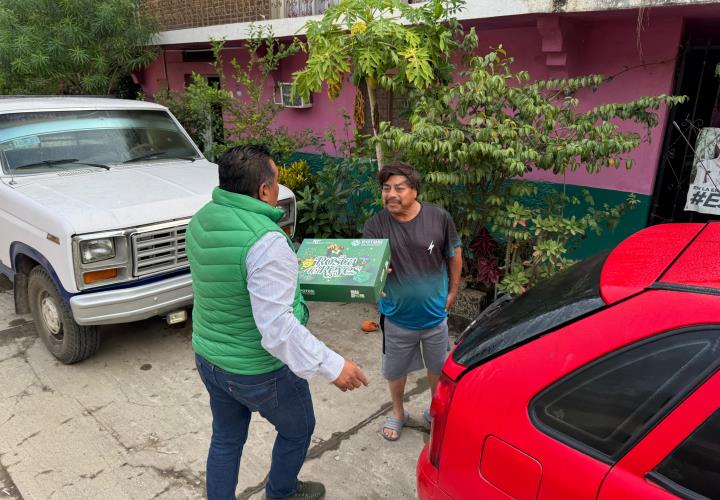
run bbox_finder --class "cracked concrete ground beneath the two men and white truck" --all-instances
[0,281,429,500]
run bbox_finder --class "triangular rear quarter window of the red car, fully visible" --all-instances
[530,328,720,463]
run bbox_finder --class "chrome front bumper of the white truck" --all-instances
[70,273,193,325]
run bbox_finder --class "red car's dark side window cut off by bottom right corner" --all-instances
[648,410,720,498]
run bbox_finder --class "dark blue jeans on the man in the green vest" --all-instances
[195,354,315,500]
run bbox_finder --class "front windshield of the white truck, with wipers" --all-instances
[0,110,198,175]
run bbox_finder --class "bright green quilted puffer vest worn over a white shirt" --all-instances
[185,188,308,375]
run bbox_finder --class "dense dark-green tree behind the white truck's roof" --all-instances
[0,0,157,95]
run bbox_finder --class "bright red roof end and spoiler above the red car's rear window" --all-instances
[600,222,720,304]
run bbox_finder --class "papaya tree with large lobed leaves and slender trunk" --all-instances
[294,0,477,168]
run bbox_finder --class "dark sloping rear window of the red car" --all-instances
[453,252,609,366]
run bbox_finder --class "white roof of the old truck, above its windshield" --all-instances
[0,96,167,114]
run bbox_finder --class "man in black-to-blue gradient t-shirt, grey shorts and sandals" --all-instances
[363,163,462,441]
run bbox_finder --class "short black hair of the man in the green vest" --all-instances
[218,144,275,198]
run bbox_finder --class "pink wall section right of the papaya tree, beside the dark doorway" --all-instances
[464,15,682,195]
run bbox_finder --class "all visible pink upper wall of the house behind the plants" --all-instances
[143,11,683,195]
